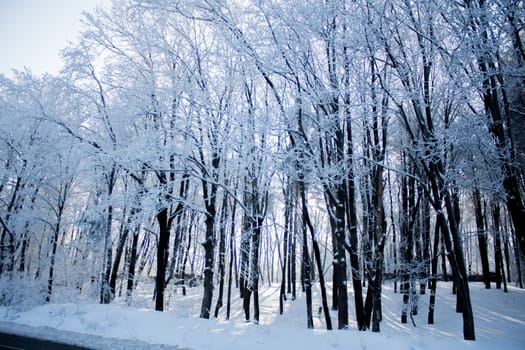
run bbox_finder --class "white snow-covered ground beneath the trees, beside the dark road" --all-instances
[0,282,525,350]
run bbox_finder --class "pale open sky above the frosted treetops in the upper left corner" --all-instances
[0,0,107,76]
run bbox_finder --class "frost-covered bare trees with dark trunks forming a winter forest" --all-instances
[0,0,525,346]
